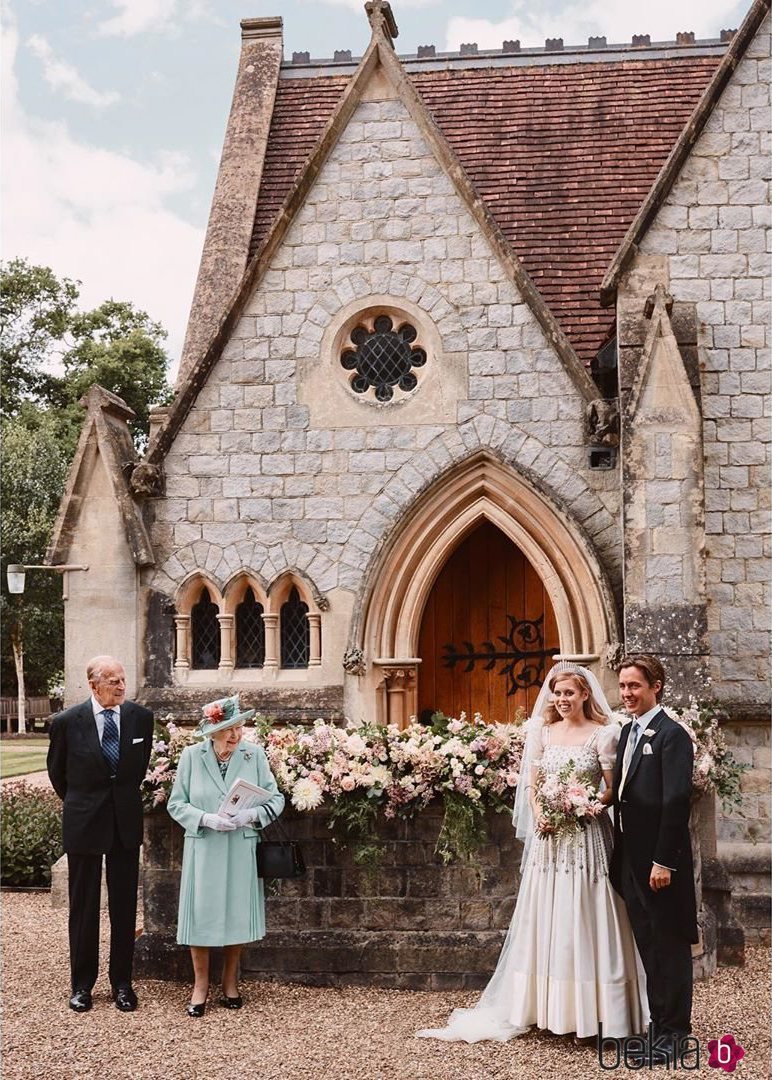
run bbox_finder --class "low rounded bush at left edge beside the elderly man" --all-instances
[0,781,62,886]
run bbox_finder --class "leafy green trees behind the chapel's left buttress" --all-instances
[0,258,172,717]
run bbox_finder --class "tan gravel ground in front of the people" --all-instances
[2,893,769,1080]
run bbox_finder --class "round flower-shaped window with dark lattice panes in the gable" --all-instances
[340,315,426,402]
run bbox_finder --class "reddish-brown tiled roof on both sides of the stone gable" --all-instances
[252,54,720,364]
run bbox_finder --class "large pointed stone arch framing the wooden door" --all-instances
[353,453,620,723]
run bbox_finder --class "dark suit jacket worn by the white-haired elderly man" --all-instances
[48,698,153,854]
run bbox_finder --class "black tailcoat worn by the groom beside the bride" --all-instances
[609,710,697,944]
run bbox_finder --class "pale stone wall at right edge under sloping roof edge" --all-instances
[640,16,772,706]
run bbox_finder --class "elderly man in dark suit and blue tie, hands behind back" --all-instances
[48,657,153,1012]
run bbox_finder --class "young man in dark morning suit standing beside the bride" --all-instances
[610,653,697,1057]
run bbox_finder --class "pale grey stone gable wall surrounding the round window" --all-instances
[146,90,621,685]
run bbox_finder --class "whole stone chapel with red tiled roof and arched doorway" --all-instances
[49,0,770,840]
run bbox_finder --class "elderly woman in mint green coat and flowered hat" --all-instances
[168,697,284,1016]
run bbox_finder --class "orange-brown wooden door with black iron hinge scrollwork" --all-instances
[418,522,559,723]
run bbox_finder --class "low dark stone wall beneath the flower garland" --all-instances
[136,807,522,989]
